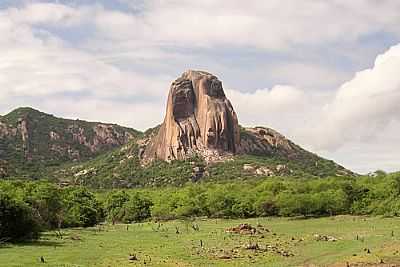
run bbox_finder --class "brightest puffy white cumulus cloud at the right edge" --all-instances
[314,44,400,151]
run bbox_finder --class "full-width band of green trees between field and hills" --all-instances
[0,172,400,243]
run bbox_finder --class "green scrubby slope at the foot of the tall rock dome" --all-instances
[46,138,352,188]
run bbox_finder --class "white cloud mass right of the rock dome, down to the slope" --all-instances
[228,44,400,172]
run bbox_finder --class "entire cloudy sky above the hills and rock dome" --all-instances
[0,0,400,173]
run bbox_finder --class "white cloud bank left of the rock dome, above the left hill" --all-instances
[0,1,170,128]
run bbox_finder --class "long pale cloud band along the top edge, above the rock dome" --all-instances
[90,0,400,50]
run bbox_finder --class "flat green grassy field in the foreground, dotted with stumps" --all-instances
[0,216,400,267]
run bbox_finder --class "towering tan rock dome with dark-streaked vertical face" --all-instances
[142,70,240,161]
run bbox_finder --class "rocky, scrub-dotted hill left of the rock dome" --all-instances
[0,108,141,176]
